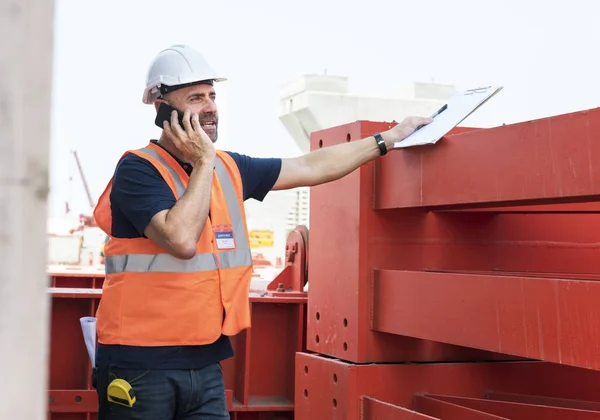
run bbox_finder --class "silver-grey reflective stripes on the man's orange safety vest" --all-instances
[105,147,252,275]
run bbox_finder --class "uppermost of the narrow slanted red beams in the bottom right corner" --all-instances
[429,395,600,420]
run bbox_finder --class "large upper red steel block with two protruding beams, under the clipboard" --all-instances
[307,113,600,367]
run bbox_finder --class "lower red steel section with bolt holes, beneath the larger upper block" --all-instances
[295,353,600,420]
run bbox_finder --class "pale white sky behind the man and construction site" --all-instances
[49,0,600,216]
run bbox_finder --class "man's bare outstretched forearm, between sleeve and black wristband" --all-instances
[304,136,380,185]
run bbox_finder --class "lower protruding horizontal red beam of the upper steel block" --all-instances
[372,270,600,370]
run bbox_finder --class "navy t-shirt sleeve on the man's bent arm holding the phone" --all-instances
[111,155,176,236]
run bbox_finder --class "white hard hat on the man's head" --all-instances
[142,45,227,104]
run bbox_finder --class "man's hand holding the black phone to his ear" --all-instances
[163,109,217,166]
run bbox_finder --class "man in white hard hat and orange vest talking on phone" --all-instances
[94,45,431,420]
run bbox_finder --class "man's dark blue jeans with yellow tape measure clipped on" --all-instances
[95,363,229,420]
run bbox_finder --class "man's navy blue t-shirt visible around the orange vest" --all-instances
[96,140,281,369]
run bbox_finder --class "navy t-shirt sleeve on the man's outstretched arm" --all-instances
[227,152,281,201]
